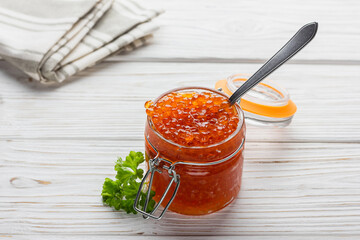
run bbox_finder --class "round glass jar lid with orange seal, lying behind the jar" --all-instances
[215,74,296,126]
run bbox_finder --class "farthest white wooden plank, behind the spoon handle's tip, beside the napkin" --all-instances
[111,0,360,64]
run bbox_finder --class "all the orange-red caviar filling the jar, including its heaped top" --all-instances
[145,88,245,215]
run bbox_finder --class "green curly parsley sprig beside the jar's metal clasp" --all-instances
[101,151,155,214]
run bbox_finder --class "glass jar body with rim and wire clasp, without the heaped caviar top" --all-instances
[134,87,245,219]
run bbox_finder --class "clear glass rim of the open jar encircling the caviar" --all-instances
[147,86,245,149]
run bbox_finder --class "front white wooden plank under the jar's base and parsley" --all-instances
[0,139,360,237]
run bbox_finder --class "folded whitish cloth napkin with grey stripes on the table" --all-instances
[0,0,161,83]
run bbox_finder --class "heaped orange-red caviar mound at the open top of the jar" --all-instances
[145,91,239,146]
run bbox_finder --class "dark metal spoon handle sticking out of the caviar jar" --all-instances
[229,22,318,105]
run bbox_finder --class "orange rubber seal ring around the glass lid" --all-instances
[215,79,297,118]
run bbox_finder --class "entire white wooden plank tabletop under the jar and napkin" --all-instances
[0,0,360,240]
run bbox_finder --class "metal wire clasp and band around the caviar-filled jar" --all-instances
[133,135,245,220]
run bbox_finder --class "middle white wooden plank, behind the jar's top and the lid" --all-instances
[0,62,360,143]
